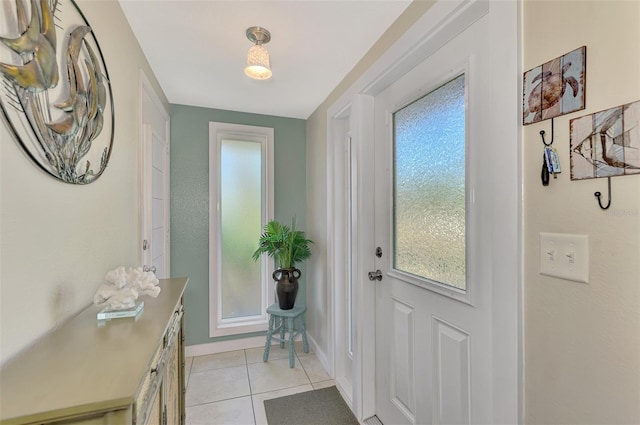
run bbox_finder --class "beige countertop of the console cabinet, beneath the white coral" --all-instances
[0,278,188,425]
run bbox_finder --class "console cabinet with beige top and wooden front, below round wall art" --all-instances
[0,278,188,425]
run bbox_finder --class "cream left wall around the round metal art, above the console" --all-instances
[0,0,166,363]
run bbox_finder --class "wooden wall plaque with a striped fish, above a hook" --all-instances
[569,101,640,180]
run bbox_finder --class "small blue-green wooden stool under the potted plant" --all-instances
[262,304,309,367]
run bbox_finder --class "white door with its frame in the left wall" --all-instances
[140,76,170,279]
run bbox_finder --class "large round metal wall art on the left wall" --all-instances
[0,0,114,184]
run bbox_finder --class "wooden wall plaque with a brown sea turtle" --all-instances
[522,46,587,125]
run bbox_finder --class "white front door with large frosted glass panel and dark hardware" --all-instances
[370,10,499,425]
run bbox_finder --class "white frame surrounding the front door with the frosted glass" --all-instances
[327,0,524,423]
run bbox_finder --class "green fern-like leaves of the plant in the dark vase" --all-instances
[252,218,313,269]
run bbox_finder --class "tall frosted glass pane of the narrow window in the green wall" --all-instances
[220,140,263,319]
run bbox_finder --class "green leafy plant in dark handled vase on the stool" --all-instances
[253,218,313,310]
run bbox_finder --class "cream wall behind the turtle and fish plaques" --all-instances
[523,0,640,424]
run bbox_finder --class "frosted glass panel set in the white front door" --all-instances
[393,75,466,290]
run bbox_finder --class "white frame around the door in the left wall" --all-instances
[138,69,171,276]
